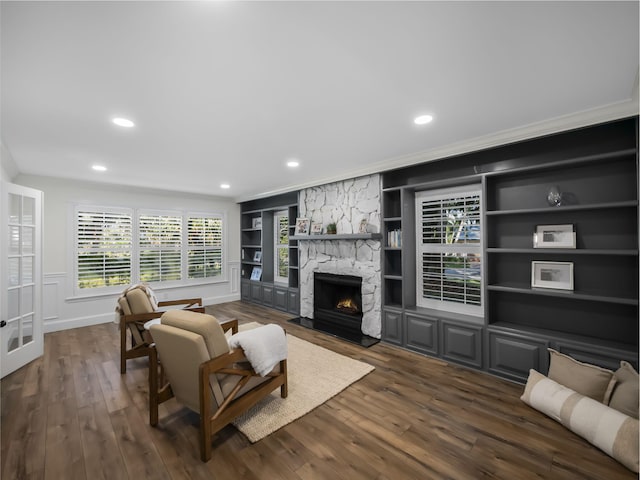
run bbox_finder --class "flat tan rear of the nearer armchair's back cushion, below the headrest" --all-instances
[151,324,209,412]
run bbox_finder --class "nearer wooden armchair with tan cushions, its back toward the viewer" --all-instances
[149,310,287,462]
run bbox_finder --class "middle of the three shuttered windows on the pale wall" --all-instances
[138,213,182,283]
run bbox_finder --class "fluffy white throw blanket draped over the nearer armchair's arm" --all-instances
[229,324,287,377]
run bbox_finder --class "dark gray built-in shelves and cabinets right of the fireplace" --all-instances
[382,118,639,382]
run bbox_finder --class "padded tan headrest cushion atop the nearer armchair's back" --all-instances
[160,310,229,358]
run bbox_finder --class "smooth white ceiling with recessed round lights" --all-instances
[0,1,639,200]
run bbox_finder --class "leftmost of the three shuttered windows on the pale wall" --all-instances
[75,208,133,289]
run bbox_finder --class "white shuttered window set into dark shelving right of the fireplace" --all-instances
[416,186,482,315]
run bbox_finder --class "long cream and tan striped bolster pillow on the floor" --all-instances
[520,370,640,473]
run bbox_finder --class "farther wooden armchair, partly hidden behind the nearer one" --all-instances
[116,285,204,373]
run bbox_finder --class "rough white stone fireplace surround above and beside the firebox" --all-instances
[298,174,382,339]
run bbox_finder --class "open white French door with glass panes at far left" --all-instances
[0,183,44,377]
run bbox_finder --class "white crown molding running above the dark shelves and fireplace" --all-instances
[235,97,640,203]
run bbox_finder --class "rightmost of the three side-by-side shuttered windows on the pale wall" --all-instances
[187,216,223,279]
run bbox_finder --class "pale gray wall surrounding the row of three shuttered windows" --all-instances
[13,174,240,332]
